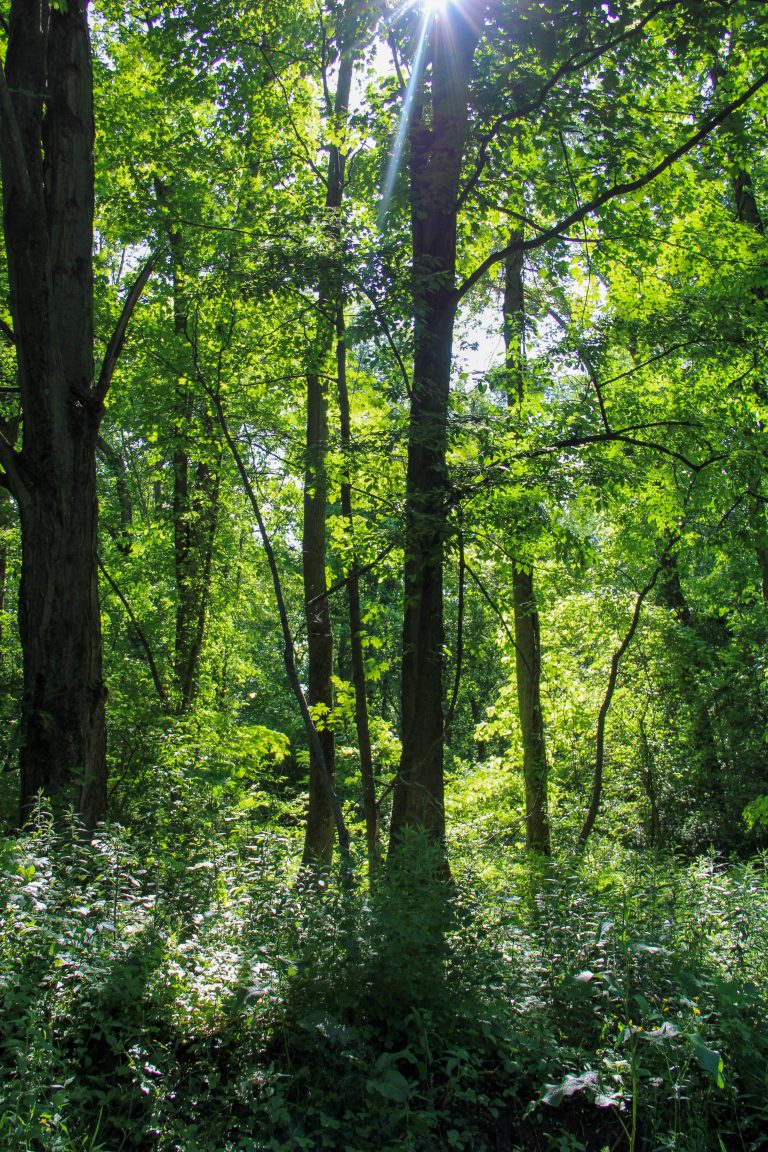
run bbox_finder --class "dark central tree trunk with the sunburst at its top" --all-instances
[390,3,480,849]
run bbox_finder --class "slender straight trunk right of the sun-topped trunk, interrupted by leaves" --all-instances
[503,243,550,856]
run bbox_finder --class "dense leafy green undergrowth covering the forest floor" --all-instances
[0,811,768,1152]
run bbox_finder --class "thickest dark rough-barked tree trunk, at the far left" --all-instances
[0,0,106,827]
